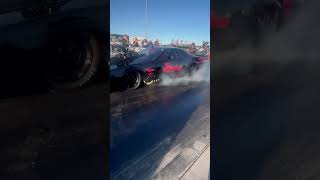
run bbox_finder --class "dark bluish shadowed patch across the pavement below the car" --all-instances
[110,87,203,173]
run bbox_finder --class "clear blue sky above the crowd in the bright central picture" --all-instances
[110,0,210,45]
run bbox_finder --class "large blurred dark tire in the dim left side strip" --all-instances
[50,32,101,90]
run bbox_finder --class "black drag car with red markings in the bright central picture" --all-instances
[110,47,198,89]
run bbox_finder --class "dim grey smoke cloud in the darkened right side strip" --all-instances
[213,0,320,75]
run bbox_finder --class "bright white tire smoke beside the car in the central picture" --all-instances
[160,63,210,86]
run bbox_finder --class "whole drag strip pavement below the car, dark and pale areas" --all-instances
[110,83,210,180]
